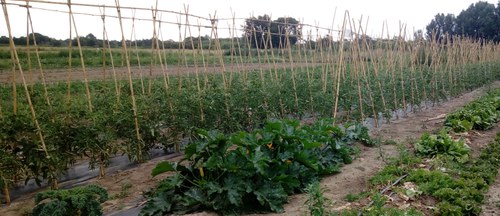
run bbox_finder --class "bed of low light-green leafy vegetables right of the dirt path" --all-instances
[342,89,500,215]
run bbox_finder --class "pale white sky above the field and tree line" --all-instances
[0,0,498,40]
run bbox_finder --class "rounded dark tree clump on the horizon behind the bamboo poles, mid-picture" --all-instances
[243,15,300,49]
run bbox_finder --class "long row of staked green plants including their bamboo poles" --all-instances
[0,30,500,206]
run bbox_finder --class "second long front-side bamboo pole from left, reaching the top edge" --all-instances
[115,0,142,154]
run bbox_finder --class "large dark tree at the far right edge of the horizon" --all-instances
[456,1,500,41]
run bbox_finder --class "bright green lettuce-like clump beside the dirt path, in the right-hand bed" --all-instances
[415,130,470,163]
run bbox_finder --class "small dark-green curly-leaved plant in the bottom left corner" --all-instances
[33,185,108,216]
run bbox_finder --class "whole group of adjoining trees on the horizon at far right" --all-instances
[426,1,500,42]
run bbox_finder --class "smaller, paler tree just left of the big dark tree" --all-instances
[426,13,456,42]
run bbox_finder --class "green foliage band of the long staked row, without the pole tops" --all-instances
[0,60,499,205]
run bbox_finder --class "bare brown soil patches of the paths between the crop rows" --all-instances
[0,81,500,216]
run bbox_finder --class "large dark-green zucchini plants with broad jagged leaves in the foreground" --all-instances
[141,120,368,215]
